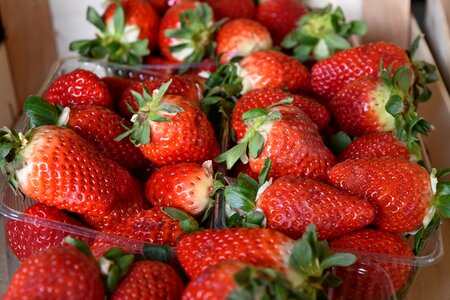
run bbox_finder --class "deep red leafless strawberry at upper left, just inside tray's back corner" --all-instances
[44,69,112,108]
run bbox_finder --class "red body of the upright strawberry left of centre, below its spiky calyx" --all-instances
[139,95,219,165]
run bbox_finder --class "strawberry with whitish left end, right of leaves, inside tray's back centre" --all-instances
[239,50,310,94]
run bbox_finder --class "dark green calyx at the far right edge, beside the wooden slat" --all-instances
[408,35,438,106]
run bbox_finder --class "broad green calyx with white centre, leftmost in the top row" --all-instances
[69,1,150,64]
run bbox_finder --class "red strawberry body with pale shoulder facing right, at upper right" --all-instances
[328,76,395,136]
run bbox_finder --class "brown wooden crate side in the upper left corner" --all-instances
[0,0,57,107]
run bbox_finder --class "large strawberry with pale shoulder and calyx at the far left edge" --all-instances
[0,125,131,216]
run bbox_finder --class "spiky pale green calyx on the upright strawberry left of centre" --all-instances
[115,80,183,146]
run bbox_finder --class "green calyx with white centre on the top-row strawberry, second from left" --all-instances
[164,2,226,68]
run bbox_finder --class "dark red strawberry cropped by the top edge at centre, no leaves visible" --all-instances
[206,0,255,20]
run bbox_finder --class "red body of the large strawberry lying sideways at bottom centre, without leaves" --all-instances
[177,228,295,278]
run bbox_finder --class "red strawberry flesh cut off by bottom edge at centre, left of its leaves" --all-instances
[182,261,248,300]
